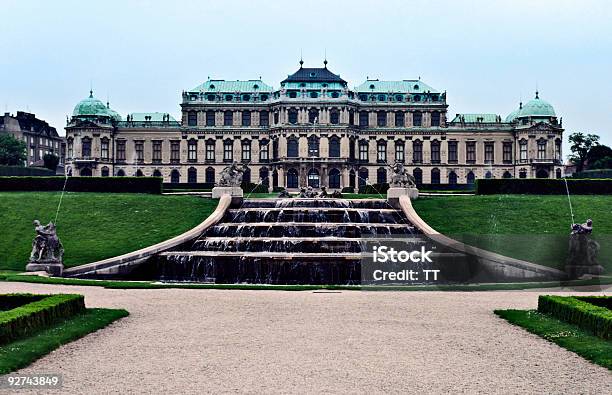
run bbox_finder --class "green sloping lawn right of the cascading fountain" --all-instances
[414,195,612,273]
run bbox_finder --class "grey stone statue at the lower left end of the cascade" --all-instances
[26,220,64,275]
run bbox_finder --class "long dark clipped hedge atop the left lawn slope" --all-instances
[0,177,162,194]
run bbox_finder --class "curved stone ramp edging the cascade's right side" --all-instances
[399,196,567,281]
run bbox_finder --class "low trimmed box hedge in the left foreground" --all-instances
[0,294,85,344]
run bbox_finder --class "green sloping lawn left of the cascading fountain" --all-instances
[0,192,217,270]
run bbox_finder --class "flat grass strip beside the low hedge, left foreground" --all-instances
[0,309,128,374]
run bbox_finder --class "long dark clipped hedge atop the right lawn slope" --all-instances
[476,178,612,195]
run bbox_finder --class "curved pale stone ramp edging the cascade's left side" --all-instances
[64,195,232,277]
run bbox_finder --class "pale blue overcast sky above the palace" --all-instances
[0,0,612,153]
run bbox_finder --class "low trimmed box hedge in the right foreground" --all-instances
[538,295,612,339]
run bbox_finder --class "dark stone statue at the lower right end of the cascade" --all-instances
[565,219,604,278]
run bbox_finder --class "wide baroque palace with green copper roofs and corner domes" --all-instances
[66,61,563,190]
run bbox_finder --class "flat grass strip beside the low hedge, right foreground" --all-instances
[495,310,612,370]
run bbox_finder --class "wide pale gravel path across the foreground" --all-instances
[0,283,612,394]
